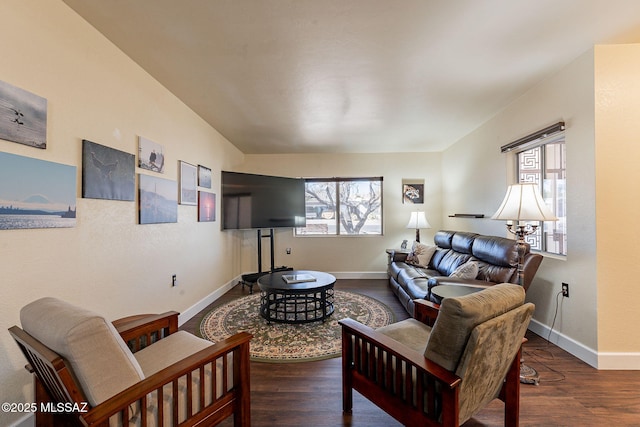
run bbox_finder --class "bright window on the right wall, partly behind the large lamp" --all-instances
[516,134,567,255]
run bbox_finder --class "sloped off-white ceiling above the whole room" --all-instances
[64,0,640,154]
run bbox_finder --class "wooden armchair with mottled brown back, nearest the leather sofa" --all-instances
[340,283,534,426]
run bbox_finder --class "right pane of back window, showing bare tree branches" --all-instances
[339,181,382,234]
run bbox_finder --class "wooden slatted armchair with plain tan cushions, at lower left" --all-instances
[9,298,251,427]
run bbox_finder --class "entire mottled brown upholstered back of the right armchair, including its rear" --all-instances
[424,283,534,423]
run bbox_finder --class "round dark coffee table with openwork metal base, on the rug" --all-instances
[258,270,336,323]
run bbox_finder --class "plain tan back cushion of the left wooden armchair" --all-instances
[20,297,144,406]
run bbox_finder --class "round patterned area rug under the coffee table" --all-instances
[199,291,395,363]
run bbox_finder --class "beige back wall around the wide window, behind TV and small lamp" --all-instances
[233,153,442,277]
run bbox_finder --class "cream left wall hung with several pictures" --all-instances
[0,0,243,425]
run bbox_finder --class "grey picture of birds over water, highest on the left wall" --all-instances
[0,81,47,149]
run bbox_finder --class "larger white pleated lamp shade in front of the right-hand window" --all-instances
[491,183,558,221]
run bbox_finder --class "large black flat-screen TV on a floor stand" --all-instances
[221,171,306,230]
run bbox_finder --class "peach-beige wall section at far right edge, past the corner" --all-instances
[595,44,640,369]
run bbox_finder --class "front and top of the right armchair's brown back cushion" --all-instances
[424,283,525,372]
